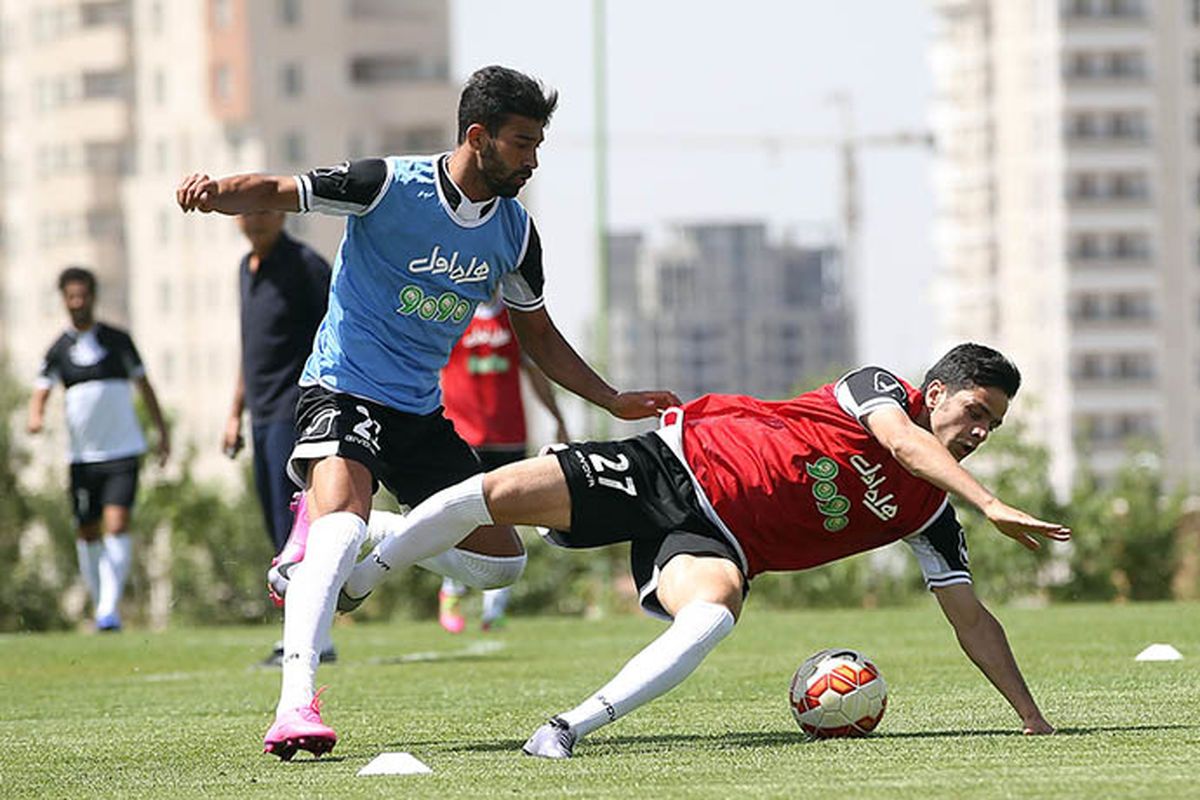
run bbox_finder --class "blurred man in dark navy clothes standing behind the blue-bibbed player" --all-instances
[221,211,337,667]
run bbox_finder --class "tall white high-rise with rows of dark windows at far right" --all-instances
[931,0,1200,489]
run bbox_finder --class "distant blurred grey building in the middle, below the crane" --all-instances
[607,223,853,417]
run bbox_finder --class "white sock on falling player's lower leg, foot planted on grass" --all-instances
[558,601,734,738]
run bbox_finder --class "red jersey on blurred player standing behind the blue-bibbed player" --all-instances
[442,305,526,447]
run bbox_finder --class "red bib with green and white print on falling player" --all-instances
[682,367,947,577]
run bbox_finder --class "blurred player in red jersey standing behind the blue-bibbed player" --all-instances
[438,291,568,633]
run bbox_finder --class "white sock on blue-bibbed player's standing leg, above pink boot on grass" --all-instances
[276,511,367,714]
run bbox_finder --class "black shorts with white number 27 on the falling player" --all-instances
[545,433,750,618]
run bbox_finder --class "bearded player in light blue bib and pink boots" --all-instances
[176,66,679,759]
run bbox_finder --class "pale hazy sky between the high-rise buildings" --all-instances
[451,0,936,379]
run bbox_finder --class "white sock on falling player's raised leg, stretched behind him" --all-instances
[346,474,493,597]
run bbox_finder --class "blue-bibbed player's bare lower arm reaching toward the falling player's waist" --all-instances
[509,308,679,420]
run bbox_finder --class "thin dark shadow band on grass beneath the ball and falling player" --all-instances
[386,724,1200,753]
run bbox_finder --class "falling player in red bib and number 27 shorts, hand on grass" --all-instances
[340,344,1070,758]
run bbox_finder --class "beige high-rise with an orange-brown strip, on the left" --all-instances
[0,0,457,482]
